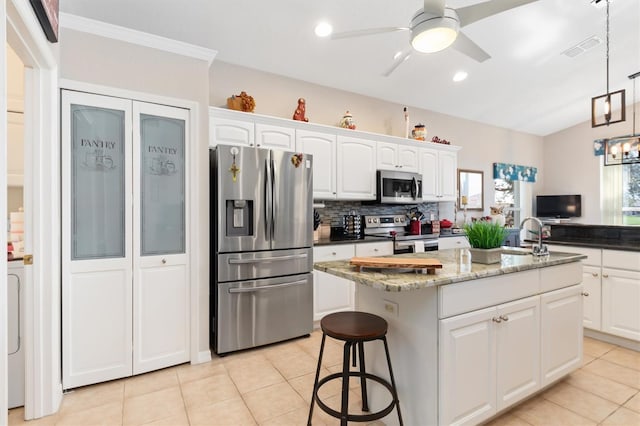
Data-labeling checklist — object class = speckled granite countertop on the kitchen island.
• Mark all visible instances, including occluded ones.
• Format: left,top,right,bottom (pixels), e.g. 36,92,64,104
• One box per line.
314,247,587,291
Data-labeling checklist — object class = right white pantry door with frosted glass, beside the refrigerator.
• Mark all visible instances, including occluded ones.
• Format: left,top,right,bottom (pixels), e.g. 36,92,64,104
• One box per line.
133,102,190,374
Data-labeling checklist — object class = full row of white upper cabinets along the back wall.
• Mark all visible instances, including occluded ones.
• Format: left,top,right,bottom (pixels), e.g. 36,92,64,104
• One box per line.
209,108,460,201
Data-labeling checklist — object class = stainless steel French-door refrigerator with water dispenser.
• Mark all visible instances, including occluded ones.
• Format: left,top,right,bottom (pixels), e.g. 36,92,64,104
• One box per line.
210,145,313,354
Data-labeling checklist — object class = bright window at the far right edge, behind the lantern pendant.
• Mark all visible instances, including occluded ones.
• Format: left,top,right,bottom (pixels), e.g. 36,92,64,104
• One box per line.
601,163,640,225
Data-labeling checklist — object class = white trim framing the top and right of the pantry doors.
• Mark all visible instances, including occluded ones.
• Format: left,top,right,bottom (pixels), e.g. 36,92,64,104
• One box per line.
59,79,211,364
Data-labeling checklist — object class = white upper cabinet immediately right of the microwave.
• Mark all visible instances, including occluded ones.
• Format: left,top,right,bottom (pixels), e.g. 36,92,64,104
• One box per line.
420,148,458,202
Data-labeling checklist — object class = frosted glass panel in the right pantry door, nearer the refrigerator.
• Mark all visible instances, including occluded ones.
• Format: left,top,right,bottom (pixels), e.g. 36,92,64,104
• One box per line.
140,114,185,256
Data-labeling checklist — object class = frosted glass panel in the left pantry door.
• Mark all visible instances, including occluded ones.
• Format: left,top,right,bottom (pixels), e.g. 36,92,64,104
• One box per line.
71,104,126,260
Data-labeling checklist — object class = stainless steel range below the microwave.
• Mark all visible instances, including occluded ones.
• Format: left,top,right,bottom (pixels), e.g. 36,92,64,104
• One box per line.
364,215,439,254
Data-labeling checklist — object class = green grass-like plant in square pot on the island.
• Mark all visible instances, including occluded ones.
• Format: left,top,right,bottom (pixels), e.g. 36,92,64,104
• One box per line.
464,220,509,264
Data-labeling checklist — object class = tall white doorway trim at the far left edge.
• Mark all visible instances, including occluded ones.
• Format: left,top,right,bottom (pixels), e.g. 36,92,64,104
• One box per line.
5,0,62,423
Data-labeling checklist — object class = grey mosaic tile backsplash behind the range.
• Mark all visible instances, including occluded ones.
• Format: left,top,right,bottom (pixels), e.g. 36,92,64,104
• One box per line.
315,201,438,226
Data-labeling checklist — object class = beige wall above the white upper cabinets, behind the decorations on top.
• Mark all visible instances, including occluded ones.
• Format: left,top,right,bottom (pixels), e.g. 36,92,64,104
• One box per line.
209,61,544,218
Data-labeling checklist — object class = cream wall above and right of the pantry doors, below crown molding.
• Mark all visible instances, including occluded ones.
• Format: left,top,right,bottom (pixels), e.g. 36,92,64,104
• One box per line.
59,28,209,352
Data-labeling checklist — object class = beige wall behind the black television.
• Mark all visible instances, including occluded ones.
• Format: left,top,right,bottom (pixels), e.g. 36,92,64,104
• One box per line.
540,102,640,224
